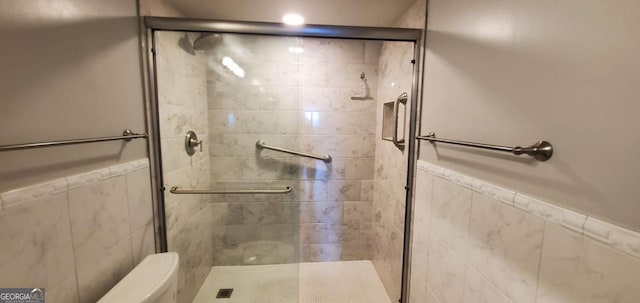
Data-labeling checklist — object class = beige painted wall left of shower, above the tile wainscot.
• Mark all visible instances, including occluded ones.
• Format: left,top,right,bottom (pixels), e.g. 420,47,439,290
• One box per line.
0,0,147,191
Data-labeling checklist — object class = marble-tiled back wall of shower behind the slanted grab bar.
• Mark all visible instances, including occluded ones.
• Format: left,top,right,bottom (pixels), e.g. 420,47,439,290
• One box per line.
207,35,380,265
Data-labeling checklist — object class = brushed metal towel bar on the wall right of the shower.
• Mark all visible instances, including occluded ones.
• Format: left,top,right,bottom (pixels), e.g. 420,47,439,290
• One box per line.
417,132,553,161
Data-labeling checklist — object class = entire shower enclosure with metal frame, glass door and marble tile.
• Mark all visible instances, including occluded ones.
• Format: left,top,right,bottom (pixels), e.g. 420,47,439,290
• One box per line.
146,18,421,303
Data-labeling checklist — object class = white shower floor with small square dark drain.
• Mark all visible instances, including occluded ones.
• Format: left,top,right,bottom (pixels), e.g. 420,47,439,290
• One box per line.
193,261,391,303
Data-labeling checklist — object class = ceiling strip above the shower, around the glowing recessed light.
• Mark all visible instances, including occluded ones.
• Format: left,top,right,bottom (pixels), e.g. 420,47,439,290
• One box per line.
169,0,415,27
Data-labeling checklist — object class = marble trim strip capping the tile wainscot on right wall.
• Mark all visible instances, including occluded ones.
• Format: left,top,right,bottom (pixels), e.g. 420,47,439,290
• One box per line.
417,160,640,258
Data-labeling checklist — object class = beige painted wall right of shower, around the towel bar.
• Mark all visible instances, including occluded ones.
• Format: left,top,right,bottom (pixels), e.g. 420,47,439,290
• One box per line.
420,0,640,230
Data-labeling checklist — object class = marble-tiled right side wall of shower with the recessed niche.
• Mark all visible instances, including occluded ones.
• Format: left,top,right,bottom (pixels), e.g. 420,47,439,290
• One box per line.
372,1,426,302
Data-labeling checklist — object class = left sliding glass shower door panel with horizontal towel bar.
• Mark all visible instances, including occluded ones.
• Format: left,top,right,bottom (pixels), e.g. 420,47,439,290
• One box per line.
155,31,300,302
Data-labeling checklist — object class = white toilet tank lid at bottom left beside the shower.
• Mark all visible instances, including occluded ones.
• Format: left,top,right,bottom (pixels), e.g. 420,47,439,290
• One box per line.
98,252,179,303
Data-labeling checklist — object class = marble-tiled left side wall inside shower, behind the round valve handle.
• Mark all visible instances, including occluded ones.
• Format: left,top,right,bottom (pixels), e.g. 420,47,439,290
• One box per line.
156,32,213,302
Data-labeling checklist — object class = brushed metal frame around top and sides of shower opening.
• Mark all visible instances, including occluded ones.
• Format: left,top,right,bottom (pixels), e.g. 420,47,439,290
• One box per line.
144,16,425,303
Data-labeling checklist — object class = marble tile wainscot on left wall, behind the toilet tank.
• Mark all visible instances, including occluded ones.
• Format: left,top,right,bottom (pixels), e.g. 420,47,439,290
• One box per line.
0,159,155,303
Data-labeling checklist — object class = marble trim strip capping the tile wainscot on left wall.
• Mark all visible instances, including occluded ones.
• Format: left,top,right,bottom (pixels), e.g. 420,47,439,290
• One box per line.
0,159,149,211
